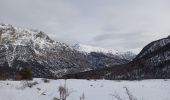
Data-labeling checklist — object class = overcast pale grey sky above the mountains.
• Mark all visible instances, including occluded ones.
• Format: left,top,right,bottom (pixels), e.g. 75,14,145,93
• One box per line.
0,0,170,53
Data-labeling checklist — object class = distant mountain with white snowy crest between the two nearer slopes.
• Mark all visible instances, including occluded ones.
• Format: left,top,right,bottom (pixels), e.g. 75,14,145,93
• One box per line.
72,44,136,68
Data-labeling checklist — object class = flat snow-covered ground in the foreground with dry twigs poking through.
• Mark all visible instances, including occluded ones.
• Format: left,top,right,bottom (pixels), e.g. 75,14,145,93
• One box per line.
0,79,170,100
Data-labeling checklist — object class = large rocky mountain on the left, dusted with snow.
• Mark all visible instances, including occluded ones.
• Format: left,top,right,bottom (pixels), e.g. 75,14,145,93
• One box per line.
0,24,93,78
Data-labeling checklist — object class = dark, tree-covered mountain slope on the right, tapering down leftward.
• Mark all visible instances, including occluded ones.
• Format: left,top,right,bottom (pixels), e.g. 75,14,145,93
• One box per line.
63,36,170,80
